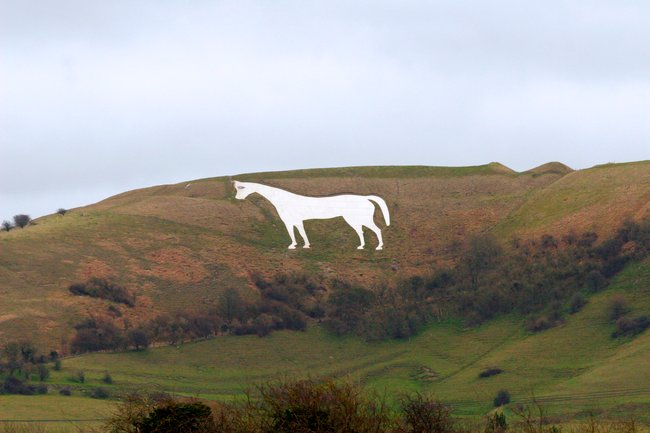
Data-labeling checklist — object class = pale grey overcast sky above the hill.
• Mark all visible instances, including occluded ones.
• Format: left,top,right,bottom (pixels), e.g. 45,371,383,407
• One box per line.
0,0,650,220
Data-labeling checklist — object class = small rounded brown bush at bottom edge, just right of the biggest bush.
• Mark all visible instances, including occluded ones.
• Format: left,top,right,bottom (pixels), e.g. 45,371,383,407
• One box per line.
401,393,454,433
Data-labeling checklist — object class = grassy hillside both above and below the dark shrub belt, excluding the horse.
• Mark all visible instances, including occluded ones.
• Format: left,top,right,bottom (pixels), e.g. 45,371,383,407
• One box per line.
0,162,650,424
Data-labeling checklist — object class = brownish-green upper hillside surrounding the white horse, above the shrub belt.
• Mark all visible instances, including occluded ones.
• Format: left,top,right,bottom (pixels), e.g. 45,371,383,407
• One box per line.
0,162,650,348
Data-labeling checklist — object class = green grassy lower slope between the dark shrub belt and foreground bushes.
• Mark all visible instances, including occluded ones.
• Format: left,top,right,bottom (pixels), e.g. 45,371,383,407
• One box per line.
5,263,650,422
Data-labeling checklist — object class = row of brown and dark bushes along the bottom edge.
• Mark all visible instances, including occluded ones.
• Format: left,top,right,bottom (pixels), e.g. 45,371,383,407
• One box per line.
105,380,640,433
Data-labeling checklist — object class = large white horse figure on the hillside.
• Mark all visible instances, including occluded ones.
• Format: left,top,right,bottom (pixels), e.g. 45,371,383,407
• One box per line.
233,181,390,250
